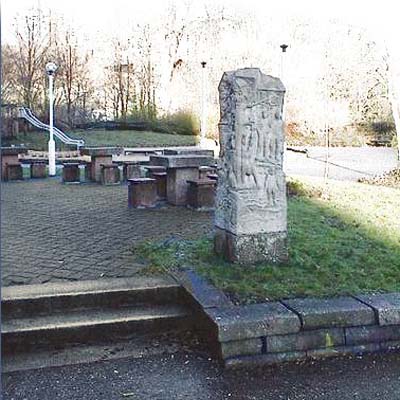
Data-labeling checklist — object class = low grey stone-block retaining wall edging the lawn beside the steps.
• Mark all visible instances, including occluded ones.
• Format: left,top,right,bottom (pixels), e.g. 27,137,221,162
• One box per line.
173,270,400,368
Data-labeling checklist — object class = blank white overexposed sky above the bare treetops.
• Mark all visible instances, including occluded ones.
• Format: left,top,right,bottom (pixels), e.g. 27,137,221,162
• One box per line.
2,0,400,46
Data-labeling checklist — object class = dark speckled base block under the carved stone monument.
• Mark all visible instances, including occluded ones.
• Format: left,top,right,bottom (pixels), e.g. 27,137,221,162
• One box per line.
214,228,288,264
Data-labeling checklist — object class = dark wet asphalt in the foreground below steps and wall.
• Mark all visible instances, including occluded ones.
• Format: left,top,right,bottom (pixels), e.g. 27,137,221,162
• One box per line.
3,351,400,400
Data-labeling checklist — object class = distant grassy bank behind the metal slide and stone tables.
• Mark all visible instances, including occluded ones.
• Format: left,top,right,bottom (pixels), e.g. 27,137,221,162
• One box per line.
3,130,196,151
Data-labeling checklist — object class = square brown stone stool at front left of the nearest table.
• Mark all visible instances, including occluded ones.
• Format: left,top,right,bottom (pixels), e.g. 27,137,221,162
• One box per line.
128,178,157,208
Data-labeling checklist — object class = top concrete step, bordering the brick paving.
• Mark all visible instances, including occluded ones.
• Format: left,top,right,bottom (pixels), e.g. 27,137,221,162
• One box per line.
1,276,182,321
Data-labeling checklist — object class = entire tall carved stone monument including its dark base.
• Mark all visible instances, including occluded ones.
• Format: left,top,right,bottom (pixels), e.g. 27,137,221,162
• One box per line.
215,68,288,264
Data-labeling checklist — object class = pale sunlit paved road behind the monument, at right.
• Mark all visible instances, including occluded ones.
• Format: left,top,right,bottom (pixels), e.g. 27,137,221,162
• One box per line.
284,147,396,181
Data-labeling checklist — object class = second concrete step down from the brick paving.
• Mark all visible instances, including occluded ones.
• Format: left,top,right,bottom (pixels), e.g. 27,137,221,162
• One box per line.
2,305,192,354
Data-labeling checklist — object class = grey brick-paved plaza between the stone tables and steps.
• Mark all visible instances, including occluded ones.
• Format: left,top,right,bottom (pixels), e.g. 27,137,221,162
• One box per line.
1,178,212,286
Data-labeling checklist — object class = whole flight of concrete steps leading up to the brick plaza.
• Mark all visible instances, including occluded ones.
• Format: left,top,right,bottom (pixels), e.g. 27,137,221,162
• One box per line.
2,277,194,370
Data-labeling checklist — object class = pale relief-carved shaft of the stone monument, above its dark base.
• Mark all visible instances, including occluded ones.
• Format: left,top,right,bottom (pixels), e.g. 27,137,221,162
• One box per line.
217,69,286,233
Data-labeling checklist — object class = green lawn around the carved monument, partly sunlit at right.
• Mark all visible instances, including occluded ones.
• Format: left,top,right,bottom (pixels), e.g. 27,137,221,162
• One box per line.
134,177,400,304
